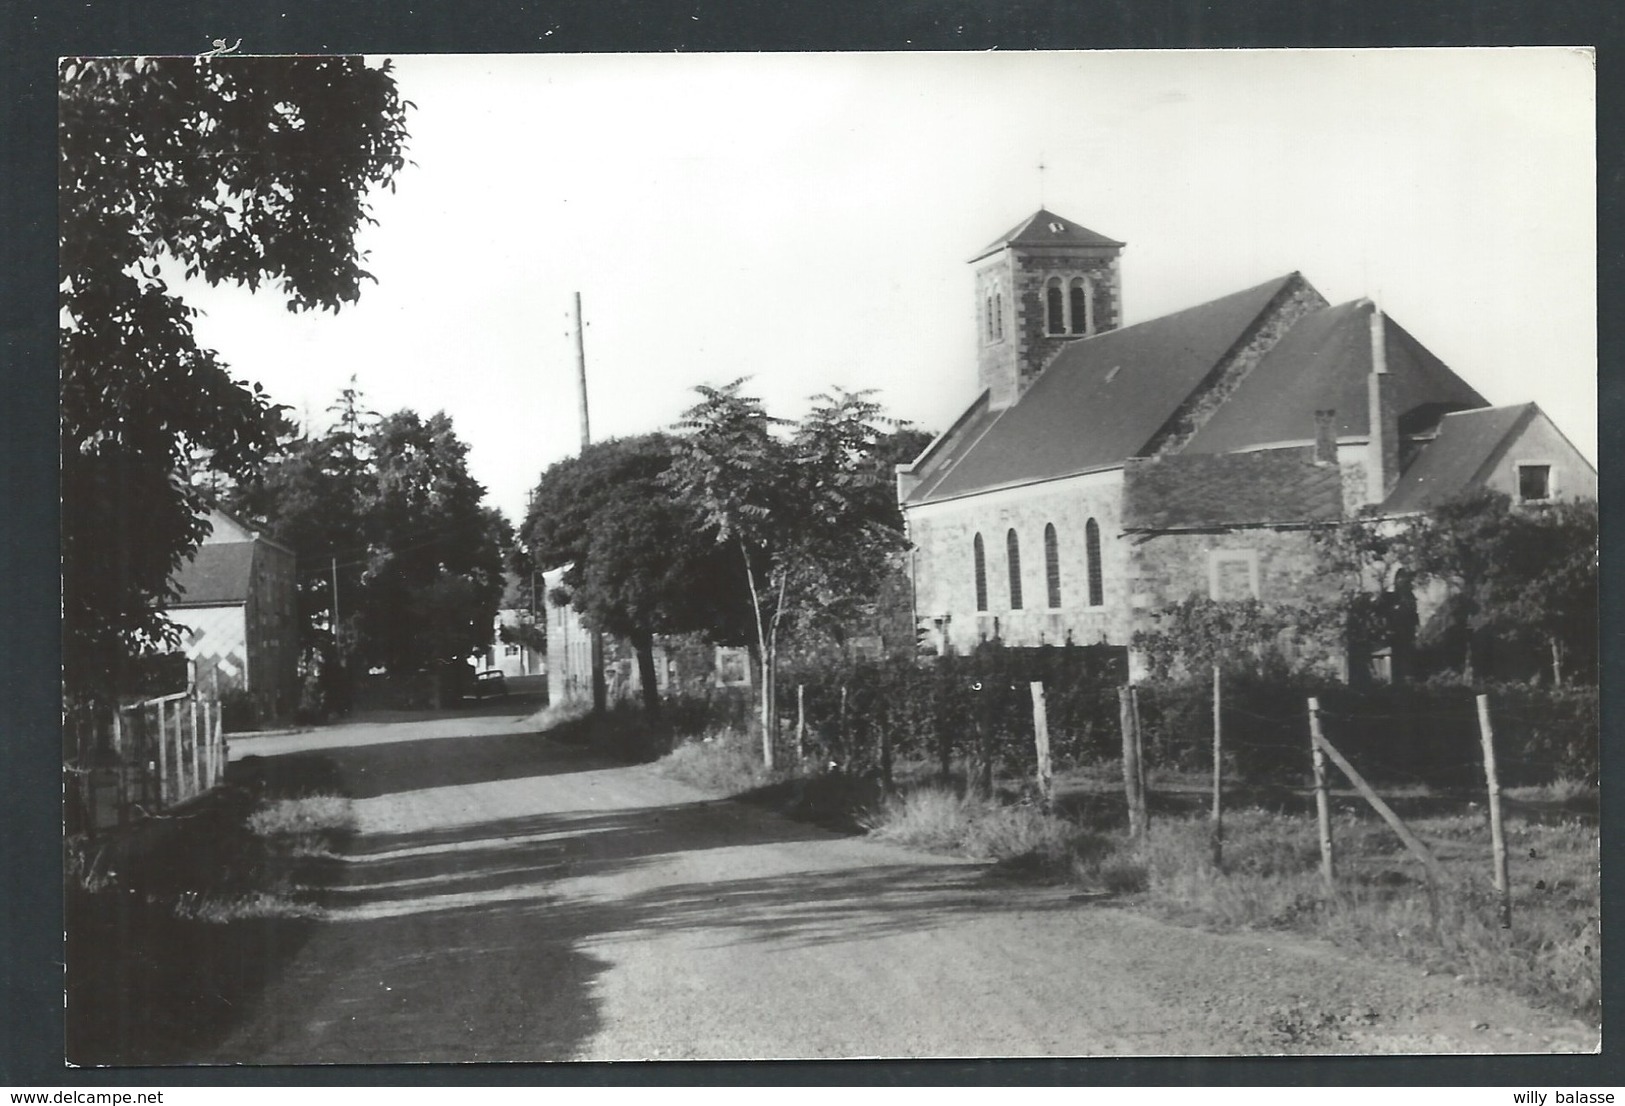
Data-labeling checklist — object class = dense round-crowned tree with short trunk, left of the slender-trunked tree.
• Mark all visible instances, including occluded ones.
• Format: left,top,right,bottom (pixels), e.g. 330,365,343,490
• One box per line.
522,434,741,710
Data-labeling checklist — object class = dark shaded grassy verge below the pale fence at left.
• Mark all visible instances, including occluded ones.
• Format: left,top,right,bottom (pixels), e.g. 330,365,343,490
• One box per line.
65,758,353,1065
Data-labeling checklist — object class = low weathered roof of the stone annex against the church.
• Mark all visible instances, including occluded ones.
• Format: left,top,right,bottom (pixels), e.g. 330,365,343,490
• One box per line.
1123,448,1342,531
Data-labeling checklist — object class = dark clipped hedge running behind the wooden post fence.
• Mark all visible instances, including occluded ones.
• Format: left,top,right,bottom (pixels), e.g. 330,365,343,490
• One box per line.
778,646,1599,788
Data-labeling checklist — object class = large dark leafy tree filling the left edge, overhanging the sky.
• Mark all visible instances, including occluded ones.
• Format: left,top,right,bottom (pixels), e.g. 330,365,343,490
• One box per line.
59,57,406,695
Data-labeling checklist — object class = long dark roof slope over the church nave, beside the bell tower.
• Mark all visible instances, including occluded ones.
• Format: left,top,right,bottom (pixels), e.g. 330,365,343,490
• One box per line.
908,273,1313,503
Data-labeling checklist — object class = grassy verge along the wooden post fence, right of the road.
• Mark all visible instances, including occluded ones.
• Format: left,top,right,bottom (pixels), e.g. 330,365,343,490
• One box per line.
606,701,1601,1023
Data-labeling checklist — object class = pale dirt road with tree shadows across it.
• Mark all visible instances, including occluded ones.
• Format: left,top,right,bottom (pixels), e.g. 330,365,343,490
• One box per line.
197,716,1594,1064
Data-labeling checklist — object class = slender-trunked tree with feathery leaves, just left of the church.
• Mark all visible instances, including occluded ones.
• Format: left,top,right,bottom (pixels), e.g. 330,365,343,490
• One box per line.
668,380,905,767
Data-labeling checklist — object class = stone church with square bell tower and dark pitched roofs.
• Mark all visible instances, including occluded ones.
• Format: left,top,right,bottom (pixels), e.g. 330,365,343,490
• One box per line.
897,210,1597,664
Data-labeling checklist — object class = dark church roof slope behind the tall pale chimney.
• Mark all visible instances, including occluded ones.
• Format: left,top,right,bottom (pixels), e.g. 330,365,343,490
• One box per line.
1181,300,1485,453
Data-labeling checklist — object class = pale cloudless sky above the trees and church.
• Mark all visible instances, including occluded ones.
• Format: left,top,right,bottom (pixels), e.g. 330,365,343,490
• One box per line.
171,49,1597,520
